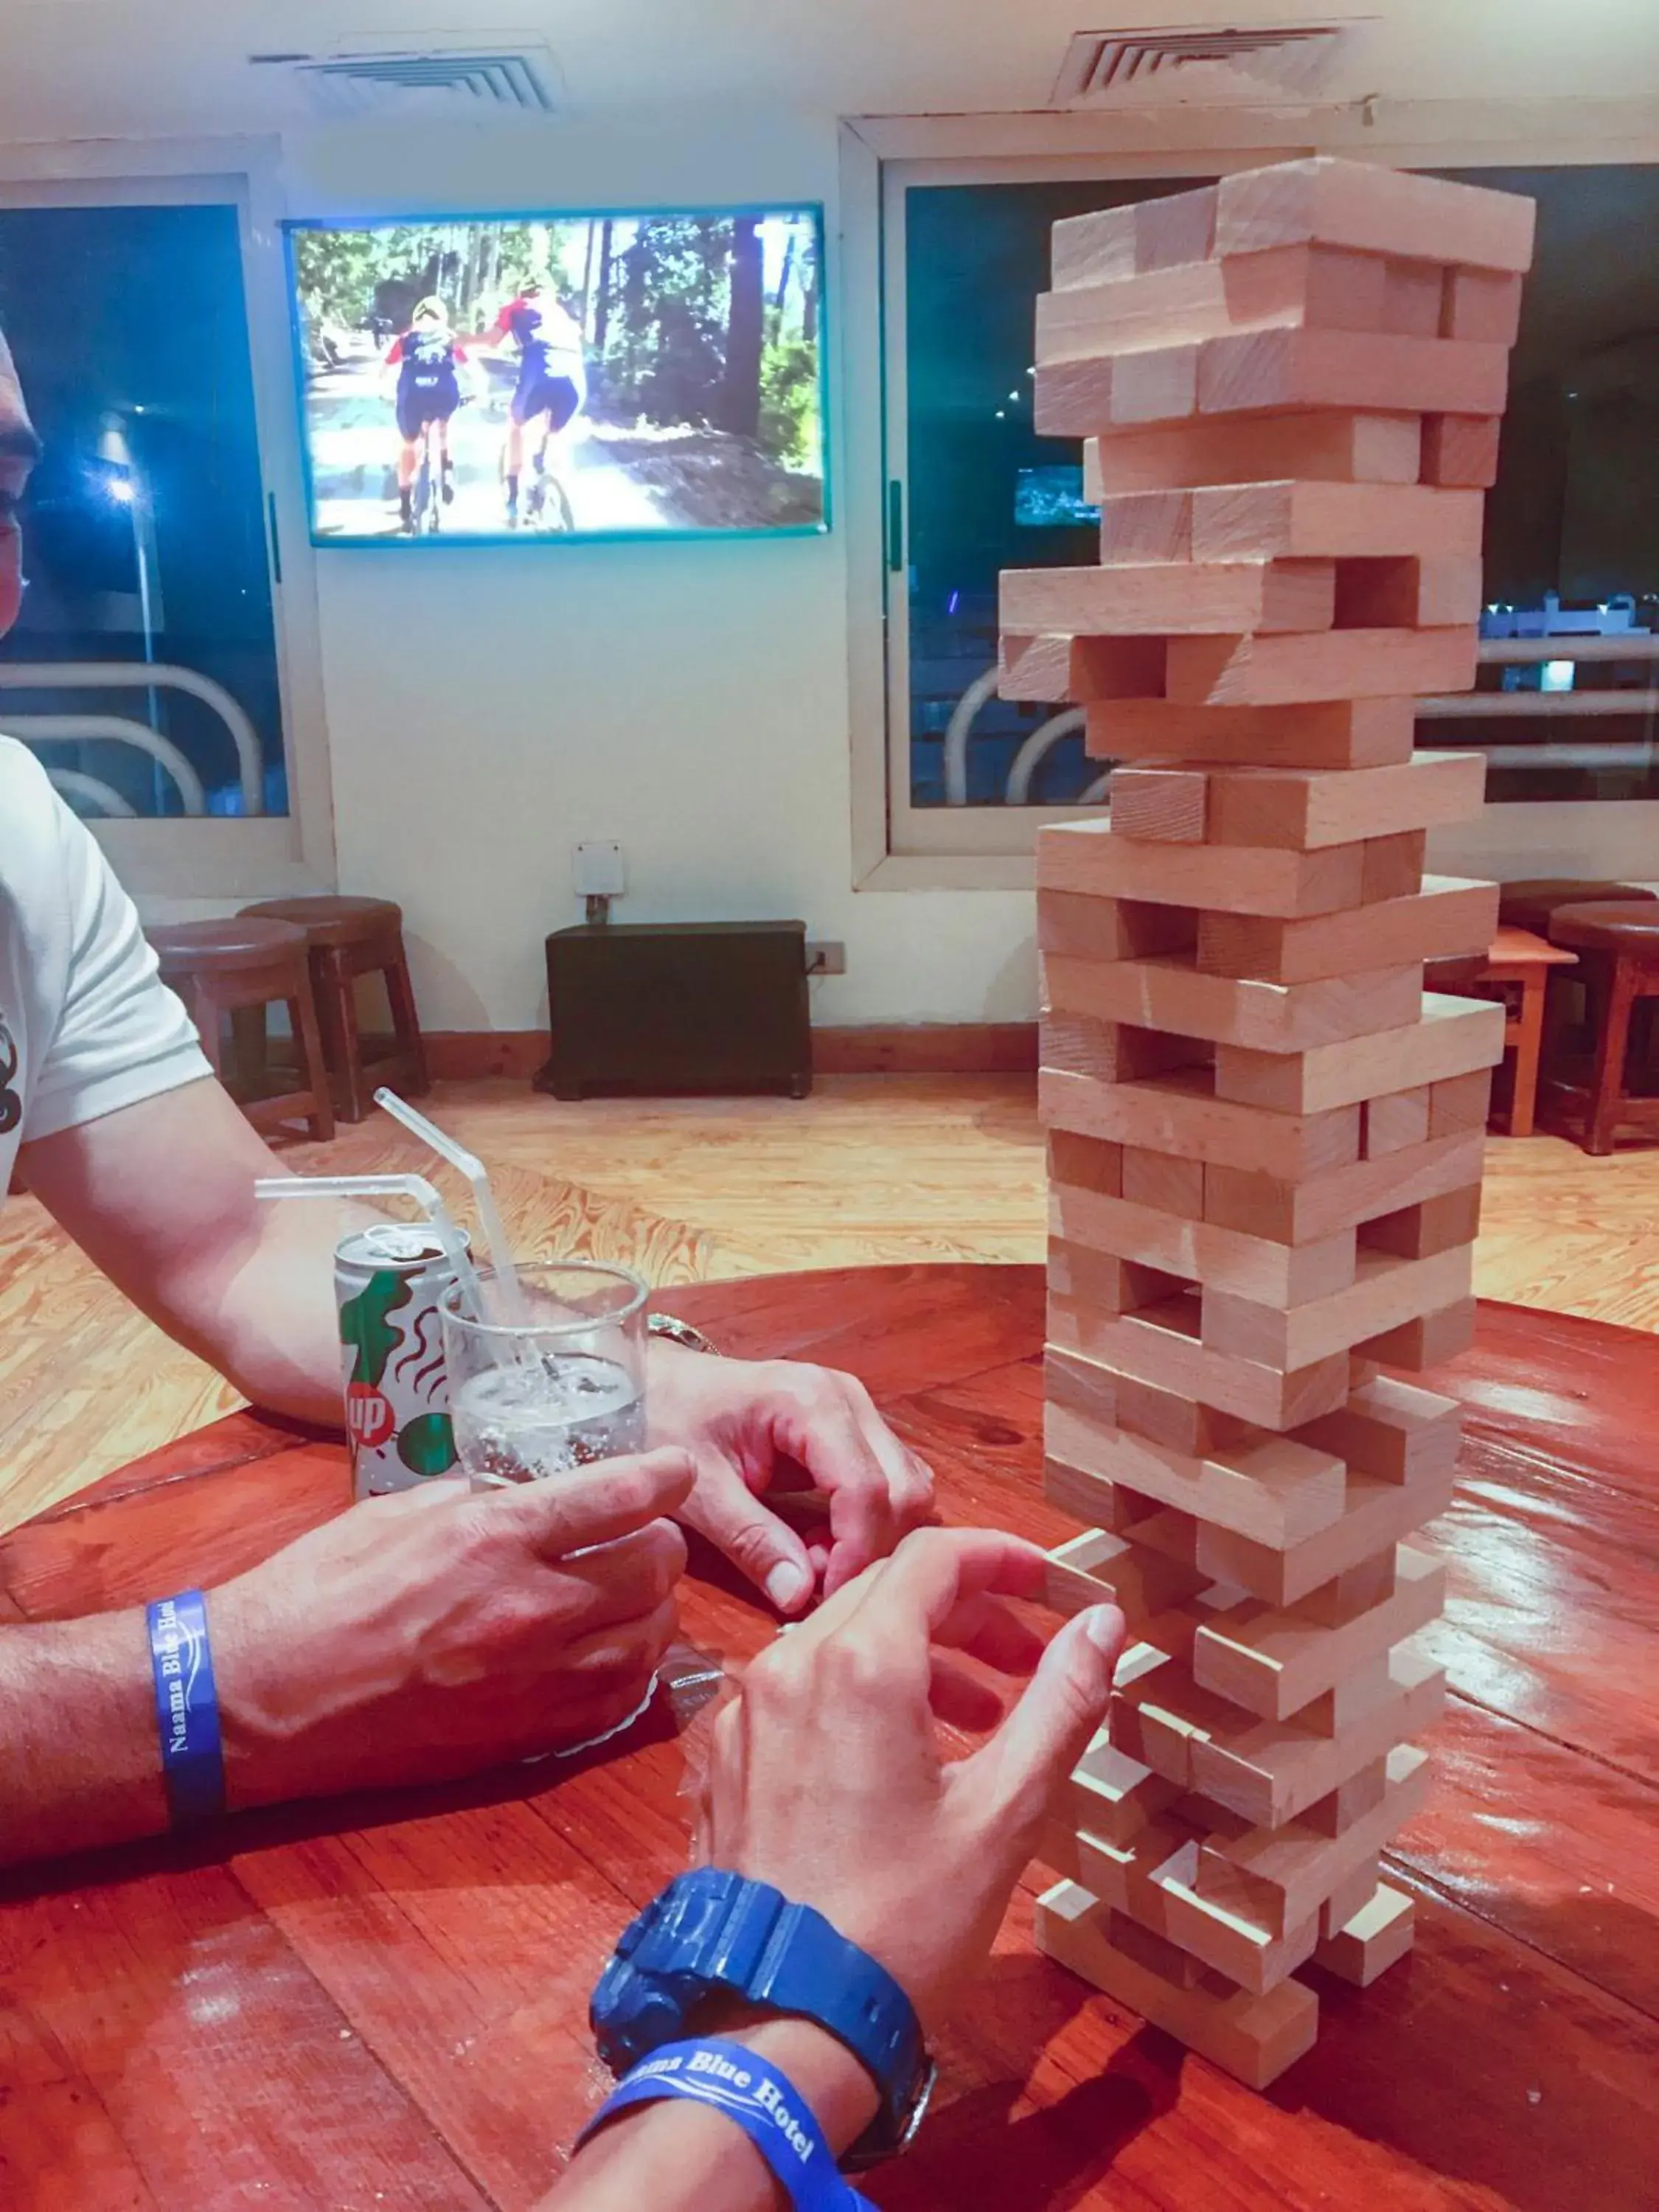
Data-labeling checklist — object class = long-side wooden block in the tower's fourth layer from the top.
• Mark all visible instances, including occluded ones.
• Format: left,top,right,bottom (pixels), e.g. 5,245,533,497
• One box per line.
1084,416,1425,504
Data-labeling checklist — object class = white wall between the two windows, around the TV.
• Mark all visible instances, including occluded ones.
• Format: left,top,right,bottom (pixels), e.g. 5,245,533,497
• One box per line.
285,117,1035,1029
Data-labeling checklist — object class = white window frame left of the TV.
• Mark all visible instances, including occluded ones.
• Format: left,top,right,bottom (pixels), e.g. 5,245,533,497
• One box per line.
0,139,336,900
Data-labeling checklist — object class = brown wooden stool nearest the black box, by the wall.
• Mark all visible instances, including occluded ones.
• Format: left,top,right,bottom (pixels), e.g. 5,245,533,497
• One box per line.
241,898,431,1121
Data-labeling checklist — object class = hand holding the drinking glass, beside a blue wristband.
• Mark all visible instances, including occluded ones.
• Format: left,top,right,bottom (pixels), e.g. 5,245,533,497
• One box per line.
208,1451,692,1807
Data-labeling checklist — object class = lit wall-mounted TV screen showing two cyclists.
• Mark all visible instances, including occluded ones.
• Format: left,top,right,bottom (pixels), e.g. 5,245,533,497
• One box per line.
288,208,830,544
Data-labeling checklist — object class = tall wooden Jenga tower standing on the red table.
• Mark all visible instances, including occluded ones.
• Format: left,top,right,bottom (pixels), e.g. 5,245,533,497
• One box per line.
1002,159,1533,2086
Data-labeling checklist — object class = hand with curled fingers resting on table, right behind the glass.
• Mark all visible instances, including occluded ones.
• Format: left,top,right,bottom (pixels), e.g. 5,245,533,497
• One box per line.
646,1340,933,1613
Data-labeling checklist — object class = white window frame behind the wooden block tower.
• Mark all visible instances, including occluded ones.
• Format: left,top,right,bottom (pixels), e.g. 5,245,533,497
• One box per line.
841,102,1659,891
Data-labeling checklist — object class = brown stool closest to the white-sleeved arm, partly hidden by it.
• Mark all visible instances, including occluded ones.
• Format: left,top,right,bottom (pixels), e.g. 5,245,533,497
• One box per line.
150,914,334,1144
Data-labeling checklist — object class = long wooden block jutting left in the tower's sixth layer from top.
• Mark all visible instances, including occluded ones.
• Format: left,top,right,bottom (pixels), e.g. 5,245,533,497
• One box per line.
1002,557,1336,637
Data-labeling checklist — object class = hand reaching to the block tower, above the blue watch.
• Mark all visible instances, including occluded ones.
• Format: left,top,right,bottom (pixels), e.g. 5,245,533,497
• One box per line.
699,1528,1124,2033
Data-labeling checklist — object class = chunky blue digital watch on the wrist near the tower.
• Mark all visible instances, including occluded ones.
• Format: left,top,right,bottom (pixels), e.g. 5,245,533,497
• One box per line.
588,1867,933,2172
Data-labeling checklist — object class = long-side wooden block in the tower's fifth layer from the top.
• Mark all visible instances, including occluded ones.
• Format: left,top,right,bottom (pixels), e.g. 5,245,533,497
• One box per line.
1186,482,1484,562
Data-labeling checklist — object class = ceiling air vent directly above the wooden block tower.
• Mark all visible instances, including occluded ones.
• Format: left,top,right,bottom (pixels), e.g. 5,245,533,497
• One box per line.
1053,18,1369,108
